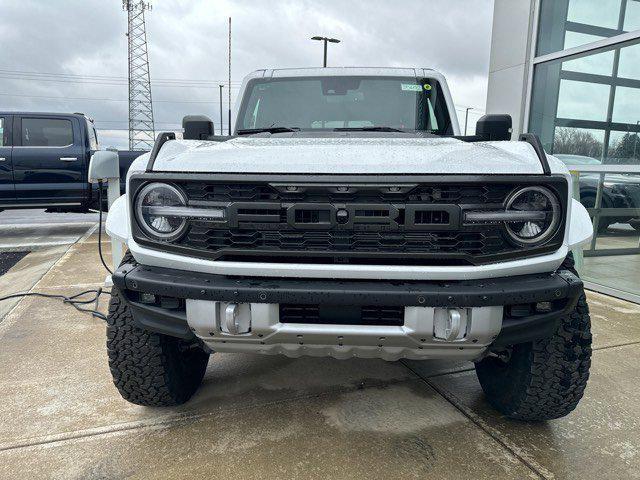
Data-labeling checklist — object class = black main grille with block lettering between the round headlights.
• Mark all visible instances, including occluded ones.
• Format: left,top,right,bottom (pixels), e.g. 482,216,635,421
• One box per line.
129,175,566,265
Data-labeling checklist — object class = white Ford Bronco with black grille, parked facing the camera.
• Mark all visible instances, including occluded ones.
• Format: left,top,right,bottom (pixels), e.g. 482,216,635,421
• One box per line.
107,68,592,420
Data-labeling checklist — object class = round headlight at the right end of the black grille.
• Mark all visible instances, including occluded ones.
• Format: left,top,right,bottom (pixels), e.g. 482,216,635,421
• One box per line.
505,187,560,246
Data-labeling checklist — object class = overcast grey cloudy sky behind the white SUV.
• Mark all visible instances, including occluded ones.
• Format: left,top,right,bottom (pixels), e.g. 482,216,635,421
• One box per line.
0,0,493,148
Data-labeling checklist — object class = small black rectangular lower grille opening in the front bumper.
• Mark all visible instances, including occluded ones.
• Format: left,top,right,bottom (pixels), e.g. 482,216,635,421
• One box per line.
280,303,404,326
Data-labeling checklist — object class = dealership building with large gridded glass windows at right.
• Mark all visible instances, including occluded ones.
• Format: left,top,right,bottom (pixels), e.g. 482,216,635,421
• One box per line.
487,0,640,302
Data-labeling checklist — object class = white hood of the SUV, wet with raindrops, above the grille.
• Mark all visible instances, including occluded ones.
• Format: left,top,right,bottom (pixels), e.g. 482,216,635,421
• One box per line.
153,136,543,175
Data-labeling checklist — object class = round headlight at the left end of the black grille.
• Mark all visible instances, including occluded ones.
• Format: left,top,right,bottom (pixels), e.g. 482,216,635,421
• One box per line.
136,183,187,241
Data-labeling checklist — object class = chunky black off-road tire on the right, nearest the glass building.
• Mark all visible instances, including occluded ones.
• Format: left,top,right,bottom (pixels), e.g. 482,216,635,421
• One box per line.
476,256,591,421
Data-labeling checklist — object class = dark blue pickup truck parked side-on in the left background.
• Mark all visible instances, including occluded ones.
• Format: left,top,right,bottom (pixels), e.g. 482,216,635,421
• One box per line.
0,111,144,212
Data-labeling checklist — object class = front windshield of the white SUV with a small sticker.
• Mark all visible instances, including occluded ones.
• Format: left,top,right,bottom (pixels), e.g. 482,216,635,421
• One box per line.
237,76,453,135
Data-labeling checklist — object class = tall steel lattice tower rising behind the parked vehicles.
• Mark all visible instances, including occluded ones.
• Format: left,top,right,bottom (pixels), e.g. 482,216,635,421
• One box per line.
122,0,155,150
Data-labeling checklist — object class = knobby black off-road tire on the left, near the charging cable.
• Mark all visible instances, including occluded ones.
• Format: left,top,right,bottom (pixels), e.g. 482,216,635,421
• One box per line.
107,254,209,407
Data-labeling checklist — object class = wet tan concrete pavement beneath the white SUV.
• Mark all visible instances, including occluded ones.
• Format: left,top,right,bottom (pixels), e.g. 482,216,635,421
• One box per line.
0,235,640,479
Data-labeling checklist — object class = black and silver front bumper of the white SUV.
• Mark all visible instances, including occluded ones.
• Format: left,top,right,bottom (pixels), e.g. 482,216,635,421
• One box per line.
113,265,582,360
